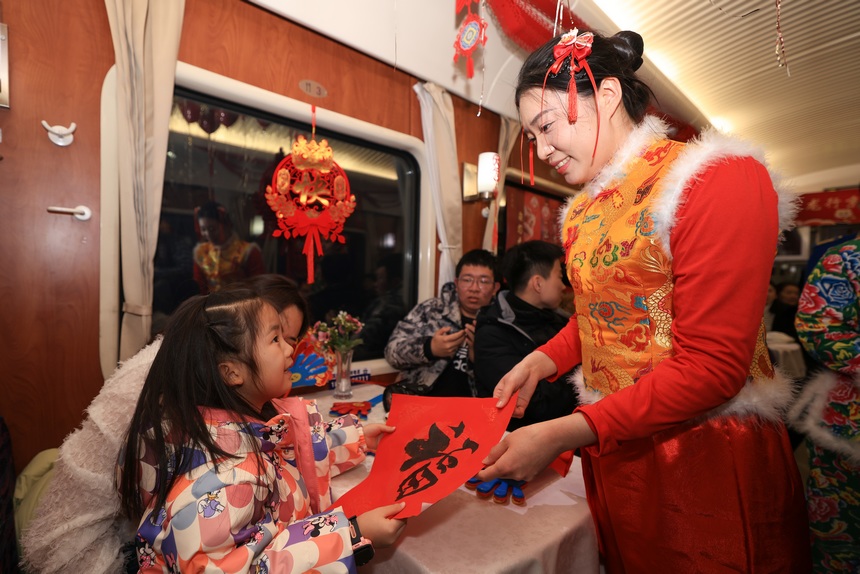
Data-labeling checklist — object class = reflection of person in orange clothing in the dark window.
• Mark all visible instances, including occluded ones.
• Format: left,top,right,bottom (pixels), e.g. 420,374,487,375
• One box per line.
194,201,266,294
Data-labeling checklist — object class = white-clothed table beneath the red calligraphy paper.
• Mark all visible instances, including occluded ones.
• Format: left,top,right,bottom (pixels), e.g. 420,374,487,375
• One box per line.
308,384,599,574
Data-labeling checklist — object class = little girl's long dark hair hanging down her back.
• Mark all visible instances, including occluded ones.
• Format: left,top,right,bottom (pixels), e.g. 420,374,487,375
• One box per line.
118,289,266,520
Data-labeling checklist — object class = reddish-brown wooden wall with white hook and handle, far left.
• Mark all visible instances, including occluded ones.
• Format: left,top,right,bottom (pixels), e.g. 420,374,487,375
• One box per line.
0,0,114,471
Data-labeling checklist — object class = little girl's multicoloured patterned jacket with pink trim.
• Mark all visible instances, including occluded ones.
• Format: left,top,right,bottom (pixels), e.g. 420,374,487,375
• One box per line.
131,399,366,573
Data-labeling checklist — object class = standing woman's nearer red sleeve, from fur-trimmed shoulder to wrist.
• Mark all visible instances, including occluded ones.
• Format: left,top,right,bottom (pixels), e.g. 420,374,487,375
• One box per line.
581,158,779,455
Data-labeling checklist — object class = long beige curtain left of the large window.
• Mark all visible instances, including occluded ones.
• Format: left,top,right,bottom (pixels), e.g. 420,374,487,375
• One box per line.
105,0,185,361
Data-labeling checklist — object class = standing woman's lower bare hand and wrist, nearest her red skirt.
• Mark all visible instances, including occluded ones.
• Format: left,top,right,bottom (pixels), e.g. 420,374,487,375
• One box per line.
476,413,597,481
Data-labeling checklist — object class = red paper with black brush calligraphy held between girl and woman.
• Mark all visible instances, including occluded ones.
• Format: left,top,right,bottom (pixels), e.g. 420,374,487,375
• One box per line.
332,394,516,518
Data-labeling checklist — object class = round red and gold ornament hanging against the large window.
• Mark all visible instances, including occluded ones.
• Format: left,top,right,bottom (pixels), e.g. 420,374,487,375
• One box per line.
266,107,355,284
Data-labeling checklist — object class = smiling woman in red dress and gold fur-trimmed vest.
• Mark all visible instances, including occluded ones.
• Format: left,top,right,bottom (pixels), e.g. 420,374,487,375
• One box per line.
478,30,810,574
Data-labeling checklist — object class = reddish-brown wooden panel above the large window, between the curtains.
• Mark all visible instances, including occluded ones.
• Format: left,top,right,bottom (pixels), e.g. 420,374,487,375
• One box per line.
179,0,421,138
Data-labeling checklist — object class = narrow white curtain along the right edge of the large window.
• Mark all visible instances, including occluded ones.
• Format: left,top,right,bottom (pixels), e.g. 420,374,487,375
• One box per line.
413,82,463,293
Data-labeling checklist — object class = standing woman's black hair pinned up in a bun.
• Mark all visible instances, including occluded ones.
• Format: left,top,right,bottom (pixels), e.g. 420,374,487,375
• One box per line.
515,31,654,123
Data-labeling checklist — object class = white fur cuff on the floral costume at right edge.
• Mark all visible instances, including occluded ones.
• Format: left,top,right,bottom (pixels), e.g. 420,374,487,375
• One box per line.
788,370,860,465
